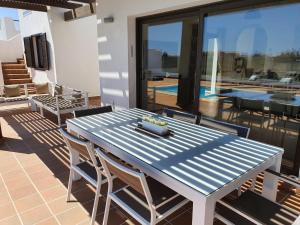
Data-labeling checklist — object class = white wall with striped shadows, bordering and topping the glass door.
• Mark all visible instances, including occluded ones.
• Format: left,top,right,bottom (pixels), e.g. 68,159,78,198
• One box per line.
97,0,221,108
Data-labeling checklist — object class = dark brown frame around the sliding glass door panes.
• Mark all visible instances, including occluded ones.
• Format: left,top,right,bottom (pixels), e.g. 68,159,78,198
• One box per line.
136,0,300,175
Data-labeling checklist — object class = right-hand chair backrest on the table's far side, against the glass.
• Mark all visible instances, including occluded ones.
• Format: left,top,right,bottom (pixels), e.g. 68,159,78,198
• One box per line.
200,116,250,138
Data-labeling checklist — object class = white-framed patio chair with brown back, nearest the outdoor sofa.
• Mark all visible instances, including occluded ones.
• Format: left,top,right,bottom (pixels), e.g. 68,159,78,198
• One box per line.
60,129,107,225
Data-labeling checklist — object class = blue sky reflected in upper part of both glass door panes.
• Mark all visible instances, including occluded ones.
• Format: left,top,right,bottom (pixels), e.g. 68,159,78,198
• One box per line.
148,3,300,56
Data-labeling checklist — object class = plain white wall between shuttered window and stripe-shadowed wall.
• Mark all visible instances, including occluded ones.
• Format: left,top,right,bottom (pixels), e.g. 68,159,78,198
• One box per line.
50,10,100,96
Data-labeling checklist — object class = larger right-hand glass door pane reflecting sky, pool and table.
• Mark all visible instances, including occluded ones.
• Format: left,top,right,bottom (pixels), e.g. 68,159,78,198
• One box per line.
199,4,300,174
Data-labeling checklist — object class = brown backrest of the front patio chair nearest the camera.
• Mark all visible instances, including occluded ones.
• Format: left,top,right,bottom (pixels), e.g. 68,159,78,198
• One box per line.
96,149,152,200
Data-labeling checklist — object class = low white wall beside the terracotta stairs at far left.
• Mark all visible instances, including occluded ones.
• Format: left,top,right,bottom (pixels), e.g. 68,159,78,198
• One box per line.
0,34,24,62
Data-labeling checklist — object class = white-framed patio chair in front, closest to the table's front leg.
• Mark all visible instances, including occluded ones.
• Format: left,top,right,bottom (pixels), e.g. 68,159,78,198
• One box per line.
96,149,189,225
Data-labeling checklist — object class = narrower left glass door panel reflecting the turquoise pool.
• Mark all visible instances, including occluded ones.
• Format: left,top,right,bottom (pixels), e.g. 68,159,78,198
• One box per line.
141,17,199,111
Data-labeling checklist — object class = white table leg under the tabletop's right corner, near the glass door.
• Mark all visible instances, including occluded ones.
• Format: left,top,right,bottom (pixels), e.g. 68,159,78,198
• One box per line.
262,155,282,202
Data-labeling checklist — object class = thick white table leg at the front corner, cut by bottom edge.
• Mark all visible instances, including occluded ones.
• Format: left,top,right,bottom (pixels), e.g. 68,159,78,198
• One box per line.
192,200,215,225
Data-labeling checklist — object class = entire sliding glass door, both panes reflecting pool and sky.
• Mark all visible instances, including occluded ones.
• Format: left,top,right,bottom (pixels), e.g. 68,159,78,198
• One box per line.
138,0,300,174
